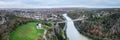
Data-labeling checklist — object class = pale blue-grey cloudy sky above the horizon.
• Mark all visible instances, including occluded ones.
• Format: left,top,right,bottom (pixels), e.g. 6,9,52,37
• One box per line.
0,0,120,8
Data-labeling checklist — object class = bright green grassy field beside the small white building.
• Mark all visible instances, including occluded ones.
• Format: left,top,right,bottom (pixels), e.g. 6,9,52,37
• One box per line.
9,22,44,40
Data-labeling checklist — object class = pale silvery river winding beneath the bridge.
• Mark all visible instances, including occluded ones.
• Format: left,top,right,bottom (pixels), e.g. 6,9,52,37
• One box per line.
63,14,88,40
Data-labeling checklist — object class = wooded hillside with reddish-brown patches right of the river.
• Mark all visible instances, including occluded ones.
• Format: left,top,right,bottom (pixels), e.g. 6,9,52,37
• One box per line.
67,9,120,40
